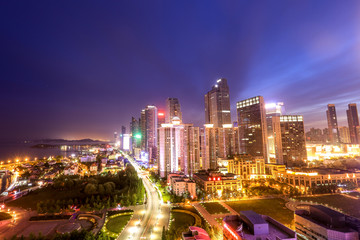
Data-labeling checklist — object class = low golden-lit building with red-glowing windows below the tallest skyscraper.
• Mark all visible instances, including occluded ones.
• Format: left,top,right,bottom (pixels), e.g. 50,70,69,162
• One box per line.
194,172,241,195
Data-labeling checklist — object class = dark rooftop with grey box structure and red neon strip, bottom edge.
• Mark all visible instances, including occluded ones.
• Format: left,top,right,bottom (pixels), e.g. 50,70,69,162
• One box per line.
222,211,296,240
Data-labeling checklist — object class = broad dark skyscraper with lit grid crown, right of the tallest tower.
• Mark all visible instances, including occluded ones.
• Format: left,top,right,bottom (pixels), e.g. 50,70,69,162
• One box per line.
236,96,268,160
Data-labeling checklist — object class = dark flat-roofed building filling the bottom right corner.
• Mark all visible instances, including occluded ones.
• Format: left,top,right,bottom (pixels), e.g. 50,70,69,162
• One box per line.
295,205,360,240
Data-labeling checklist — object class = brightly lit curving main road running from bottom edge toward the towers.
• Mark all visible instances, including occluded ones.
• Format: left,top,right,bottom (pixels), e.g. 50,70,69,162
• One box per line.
117,154,170,240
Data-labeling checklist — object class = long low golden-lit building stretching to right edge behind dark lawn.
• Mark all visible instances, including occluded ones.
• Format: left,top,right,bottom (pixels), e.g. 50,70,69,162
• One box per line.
274,168,360,191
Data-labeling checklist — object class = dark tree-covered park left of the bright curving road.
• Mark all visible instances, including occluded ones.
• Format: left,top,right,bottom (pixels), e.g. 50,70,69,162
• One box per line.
10,165,145,214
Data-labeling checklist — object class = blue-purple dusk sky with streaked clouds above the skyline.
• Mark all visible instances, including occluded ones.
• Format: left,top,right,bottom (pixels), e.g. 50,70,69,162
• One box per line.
0,0,360,139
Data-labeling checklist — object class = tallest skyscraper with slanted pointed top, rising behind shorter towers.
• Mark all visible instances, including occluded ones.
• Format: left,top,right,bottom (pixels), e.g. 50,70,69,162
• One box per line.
205,78,231,127
